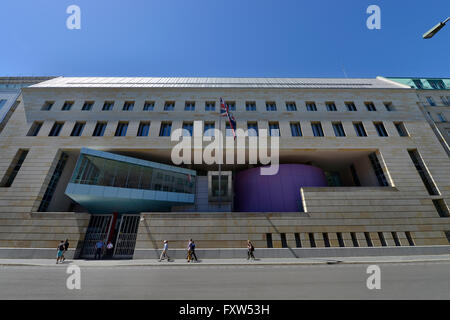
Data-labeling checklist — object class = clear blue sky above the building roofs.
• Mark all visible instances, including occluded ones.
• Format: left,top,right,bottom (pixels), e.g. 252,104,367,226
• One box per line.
0,0,450,78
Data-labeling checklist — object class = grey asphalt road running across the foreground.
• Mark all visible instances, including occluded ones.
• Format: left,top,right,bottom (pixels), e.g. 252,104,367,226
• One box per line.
0,261,450,300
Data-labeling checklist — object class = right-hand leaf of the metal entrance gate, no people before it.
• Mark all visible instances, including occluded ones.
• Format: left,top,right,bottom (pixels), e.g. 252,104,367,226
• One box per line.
114,214,140,259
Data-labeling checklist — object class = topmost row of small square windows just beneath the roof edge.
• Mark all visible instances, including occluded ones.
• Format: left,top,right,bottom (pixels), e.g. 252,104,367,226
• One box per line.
41,101,394,111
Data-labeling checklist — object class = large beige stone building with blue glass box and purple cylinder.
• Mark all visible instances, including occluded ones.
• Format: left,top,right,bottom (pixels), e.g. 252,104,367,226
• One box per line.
0,77,450,257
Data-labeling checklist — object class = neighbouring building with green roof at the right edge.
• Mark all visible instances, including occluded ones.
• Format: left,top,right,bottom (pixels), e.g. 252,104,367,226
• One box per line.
387,78,450,156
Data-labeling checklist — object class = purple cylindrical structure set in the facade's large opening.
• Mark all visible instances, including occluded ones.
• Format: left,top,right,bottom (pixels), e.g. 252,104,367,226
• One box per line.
234,164,328,212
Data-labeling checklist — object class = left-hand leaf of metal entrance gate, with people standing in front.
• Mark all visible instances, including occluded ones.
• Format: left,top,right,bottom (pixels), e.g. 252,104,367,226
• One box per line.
80,214,113,259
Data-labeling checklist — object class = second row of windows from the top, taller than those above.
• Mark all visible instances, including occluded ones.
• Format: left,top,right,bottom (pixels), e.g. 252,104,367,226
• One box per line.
27,121,409,137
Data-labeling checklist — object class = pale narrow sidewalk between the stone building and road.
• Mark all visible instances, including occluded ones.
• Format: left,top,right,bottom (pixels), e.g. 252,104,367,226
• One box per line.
0,255,450,267
